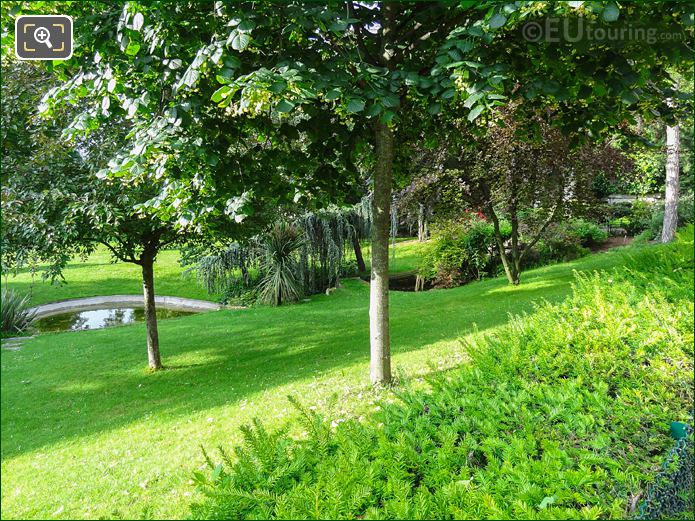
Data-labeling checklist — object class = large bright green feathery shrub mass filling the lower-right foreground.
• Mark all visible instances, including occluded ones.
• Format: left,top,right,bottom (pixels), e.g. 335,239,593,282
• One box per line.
192,226,693,519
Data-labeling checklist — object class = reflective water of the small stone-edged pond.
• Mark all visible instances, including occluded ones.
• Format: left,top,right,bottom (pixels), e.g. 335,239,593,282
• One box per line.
34,307,195,331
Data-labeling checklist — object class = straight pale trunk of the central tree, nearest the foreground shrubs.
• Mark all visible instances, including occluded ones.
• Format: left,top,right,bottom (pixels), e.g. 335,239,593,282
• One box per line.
369,121,394,383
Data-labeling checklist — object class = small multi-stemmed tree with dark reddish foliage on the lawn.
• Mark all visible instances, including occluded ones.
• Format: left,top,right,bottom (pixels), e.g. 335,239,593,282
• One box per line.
445,108,592,284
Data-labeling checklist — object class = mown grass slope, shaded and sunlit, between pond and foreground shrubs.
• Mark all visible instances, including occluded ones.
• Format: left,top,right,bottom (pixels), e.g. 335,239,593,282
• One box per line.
2,245,640,518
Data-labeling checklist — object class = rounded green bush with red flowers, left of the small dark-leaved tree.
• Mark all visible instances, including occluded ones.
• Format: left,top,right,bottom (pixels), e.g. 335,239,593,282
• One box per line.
419,214,511,288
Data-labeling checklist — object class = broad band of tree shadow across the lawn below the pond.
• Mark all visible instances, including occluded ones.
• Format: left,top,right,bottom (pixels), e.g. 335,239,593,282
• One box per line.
1,246,632,459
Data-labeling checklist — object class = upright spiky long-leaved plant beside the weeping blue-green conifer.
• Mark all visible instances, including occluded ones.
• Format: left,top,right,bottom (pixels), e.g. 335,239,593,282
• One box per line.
259,222,302,306
